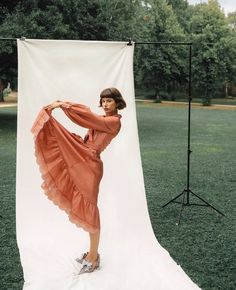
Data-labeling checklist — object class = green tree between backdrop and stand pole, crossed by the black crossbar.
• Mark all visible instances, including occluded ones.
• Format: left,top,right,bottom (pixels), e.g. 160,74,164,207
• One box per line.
136,0,187,95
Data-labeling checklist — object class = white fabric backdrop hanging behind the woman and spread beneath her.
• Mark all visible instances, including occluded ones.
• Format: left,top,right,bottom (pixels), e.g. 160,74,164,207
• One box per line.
16,39,199,290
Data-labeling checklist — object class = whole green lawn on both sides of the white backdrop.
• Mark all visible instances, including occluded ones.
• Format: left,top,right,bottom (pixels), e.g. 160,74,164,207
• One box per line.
0,104,236,290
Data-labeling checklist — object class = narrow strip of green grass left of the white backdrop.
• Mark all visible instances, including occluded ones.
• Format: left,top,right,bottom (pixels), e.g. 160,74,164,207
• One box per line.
0,108,23,290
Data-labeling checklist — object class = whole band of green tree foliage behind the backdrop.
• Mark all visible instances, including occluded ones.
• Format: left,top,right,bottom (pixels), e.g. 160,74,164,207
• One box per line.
0,0,236,99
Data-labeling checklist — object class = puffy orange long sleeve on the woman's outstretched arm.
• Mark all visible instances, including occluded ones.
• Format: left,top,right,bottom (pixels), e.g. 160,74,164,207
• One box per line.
61,102,120,134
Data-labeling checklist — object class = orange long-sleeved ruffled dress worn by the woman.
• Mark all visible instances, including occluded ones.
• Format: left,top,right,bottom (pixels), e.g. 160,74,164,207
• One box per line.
31,102,121,233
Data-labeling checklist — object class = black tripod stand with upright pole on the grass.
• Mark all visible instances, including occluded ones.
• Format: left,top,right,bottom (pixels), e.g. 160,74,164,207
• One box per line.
162,43,225,225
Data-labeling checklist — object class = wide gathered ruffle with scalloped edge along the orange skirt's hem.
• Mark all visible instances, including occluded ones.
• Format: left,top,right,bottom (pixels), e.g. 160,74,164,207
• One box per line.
31,109,100,232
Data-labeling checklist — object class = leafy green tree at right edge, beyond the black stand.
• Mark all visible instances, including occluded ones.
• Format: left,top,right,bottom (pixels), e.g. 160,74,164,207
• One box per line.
190,0,236,105
